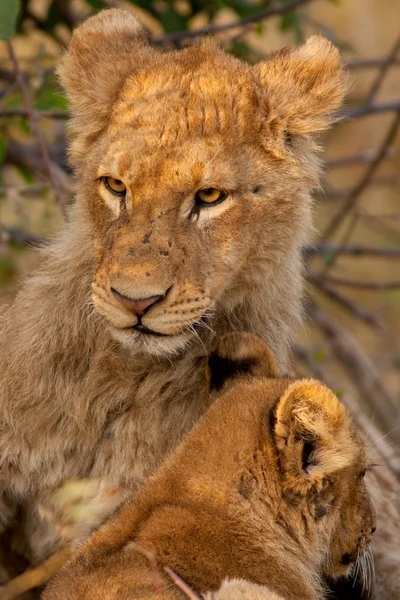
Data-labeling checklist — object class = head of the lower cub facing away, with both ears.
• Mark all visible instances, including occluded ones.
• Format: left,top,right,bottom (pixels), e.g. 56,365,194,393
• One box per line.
206,333,375,578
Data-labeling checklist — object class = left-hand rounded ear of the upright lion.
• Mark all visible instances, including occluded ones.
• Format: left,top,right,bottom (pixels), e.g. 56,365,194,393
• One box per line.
58,9,154,159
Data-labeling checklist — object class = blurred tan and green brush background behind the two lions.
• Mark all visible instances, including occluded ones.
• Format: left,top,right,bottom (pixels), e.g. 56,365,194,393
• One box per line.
0,0,400,475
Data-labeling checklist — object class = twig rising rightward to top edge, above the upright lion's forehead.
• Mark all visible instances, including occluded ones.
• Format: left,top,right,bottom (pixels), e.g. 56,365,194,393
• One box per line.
152,0,315,46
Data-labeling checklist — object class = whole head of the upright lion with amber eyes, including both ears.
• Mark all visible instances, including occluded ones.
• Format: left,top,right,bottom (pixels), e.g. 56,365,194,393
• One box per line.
60,10,344,354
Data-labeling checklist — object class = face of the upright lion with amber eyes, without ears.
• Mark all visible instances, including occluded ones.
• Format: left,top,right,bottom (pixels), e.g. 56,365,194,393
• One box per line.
90,125,279,353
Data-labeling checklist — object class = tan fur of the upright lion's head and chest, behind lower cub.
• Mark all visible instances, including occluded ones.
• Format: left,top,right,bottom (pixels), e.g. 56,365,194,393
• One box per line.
0,10,345,563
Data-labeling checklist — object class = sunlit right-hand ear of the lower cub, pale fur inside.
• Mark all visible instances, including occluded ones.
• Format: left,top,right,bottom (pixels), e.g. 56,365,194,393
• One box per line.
274,379,360,493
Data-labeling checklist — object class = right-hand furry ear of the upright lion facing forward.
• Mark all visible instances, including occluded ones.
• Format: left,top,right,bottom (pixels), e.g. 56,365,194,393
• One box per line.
254,35,348,154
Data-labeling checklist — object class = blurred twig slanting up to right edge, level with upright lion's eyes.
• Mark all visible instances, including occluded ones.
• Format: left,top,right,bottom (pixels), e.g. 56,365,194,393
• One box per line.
322,107,400,241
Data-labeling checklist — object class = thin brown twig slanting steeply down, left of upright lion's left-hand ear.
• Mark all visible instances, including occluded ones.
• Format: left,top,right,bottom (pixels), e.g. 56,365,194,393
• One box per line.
7,40,67,218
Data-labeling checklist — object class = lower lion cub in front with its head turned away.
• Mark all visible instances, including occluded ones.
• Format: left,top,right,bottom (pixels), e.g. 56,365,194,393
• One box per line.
43,333,375,600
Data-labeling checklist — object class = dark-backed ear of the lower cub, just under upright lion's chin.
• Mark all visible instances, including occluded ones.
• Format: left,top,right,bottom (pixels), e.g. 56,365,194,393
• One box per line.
207,332,278,390
